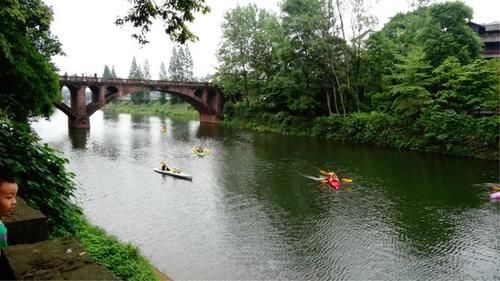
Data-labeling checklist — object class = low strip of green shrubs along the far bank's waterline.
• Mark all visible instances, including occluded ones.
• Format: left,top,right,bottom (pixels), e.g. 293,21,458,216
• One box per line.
223,112,500,160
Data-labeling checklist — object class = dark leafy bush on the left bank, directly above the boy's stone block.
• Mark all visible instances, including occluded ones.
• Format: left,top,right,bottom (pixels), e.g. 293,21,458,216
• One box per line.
0,114,81,235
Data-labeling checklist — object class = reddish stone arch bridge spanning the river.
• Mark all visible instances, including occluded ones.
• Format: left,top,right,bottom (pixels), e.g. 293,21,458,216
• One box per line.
56,76,224,128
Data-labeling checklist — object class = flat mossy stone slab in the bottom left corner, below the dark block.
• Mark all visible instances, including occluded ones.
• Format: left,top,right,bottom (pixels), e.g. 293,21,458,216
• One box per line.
4,238,119,280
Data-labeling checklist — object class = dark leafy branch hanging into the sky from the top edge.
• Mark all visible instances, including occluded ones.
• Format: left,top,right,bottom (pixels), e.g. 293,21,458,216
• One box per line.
115,0,210,44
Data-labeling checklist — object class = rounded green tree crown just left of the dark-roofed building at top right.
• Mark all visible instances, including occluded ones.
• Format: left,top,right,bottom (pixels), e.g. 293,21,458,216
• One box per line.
381,1,481,67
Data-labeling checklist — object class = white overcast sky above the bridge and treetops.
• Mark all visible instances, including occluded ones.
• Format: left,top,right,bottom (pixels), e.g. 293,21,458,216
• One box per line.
44,0,500,79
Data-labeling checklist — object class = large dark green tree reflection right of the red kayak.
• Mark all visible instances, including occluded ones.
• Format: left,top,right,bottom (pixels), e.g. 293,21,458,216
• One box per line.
337,144,491,254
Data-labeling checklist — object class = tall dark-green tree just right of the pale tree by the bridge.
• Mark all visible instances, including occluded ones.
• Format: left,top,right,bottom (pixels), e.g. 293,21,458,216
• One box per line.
278,0,329,116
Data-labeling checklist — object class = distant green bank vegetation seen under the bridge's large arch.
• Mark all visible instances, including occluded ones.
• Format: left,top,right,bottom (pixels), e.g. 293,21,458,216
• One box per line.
103,101,199,119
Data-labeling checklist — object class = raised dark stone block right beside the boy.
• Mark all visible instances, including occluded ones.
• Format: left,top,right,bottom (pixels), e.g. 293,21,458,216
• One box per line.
0,197,49,245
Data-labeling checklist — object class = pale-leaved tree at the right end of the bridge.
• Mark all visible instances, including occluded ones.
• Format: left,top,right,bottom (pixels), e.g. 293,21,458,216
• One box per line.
215,5,286,109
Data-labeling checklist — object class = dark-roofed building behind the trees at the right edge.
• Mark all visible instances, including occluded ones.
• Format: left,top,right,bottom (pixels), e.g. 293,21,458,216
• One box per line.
469,21,500,58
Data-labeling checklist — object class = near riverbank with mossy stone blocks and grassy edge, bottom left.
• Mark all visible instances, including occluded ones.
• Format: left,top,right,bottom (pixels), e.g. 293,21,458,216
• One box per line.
0,197,171,280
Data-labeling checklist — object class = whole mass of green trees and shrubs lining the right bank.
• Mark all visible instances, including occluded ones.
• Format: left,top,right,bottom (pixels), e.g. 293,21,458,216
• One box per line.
215,0,500,159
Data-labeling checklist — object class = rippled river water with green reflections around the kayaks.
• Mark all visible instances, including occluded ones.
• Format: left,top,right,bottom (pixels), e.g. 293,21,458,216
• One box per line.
33,111,500,280
